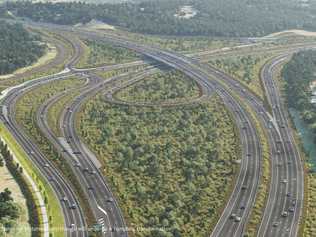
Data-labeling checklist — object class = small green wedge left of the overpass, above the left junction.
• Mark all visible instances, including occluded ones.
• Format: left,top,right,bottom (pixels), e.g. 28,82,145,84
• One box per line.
78,40,138,68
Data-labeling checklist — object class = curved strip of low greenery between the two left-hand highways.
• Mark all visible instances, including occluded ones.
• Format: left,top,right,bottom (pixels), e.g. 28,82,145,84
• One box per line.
16,78,98,230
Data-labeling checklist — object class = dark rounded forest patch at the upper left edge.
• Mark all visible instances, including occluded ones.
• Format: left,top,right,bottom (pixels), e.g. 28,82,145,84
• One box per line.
0,21,46,75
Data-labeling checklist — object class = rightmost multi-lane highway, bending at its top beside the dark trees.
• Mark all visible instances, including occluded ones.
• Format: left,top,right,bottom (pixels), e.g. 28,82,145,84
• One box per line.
259,55,304,236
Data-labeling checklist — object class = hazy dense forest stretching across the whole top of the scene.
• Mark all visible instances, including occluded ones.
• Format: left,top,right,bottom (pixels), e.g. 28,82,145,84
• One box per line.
1,0,316,37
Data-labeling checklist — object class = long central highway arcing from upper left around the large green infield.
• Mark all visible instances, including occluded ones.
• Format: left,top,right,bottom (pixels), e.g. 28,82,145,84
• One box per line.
16,21,274,236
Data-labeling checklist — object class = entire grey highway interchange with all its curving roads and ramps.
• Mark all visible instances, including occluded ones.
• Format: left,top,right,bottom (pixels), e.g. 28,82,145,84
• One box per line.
1,20,312,237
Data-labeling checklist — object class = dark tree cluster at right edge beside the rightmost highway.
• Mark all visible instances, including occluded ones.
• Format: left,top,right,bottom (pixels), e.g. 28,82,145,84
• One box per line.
282,50,316,139
